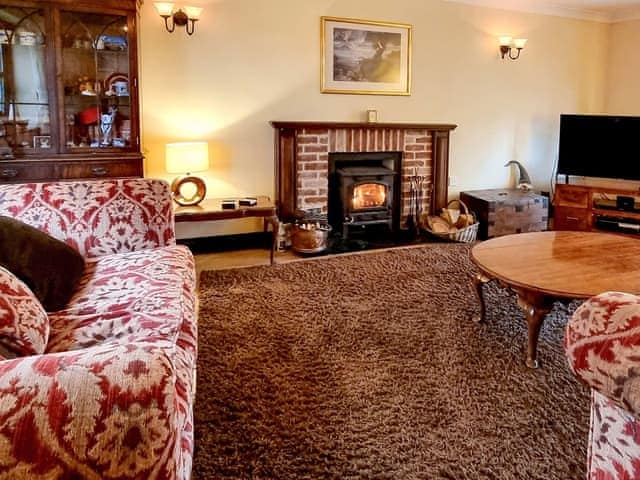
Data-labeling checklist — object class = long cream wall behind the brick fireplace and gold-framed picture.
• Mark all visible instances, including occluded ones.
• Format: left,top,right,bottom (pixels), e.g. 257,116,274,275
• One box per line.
140,0,608,234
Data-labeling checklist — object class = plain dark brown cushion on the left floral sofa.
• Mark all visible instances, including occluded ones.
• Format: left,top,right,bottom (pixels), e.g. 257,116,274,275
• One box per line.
0,216,84,312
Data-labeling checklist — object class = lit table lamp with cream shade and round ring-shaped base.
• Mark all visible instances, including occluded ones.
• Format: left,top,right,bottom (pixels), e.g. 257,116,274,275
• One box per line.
165,142,209,206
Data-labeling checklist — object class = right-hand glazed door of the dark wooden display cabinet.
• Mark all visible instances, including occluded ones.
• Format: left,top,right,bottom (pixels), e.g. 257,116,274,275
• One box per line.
60,11,137,153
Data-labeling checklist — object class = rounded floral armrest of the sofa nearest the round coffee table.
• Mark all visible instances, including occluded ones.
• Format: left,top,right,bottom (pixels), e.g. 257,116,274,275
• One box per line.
564,292,640,419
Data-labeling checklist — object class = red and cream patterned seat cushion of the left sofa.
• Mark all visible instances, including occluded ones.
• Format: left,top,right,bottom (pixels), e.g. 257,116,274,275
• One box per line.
47,246,195,352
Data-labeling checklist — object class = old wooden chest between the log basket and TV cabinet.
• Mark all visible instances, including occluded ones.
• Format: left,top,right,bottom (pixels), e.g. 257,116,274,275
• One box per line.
460,188,549,239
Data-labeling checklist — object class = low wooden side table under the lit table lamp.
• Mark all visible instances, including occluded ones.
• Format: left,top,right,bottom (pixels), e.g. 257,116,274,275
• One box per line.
173,196,279,265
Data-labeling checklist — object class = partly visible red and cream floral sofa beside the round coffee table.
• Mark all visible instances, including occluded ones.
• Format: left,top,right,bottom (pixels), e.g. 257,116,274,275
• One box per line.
564,292,640,480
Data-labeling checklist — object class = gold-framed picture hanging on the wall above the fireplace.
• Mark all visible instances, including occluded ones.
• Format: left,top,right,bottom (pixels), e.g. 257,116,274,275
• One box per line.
320,17,411,95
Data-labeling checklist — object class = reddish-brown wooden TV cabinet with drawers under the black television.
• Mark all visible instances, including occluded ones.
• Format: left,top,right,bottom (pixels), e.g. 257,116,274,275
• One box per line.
553,184,640,231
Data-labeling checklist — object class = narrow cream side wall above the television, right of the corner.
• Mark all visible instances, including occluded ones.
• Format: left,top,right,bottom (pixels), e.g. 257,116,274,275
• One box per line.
606,20,640,115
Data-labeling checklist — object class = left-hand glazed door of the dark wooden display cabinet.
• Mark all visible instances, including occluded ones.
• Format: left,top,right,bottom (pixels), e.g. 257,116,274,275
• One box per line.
0,6,56,156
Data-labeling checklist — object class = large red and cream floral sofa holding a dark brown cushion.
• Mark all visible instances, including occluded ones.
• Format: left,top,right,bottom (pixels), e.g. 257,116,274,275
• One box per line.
0,179,197,479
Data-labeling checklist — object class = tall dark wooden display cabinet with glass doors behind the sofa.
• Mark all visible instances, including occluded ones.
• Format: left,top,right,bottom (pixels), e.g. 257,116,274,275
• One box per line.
0,0,142,183
